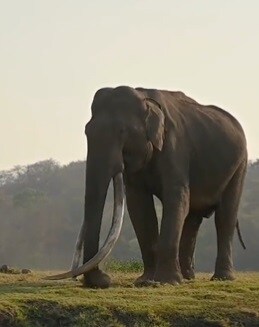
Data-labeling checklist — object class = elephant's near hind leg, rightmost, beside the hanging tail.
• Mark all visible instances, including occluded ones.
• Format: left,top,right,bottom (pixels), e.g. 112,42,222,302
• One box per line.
212,164,246,280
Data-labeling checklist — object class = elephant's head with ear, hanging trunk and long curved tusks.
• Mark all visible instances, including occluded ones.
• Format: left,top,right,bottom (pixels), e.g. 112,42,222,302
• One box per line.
46,86,164,286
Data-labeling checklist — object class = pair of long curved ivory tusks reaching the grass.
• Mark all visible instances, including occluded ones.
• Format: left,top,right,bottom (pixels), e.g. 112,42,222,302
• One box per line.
45,173,125,280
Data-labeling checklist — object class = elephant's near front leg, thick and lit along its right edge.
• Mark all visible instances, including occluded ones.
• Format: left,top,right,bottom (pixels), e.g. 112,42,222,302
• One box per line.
154,187,189,284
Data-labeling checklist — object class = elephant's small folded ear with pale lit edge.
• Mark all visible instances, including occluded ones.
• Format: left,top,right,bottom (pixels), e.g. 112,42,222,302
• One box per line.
145,98,165,151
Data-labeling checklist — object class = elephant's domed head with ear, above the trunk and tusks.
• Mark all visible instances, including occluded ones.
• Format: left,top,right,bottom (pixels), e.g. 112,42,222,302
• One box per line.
85,87,164,176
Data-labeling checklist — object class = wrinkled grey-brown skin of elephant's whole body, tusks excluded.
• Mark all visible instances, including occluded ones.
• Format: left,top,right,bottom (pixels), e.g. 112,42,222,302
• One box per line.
83,86,247,288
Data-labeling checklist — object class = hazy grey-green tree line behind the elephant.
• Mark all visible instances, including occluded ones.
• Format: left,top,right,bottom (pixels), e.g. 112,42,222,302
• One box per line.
0,159,259,271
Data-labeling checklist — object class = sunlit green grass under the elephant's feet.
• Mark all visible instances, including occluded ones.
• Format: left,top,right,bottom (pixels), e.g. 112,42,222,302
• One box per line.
0,263,259,327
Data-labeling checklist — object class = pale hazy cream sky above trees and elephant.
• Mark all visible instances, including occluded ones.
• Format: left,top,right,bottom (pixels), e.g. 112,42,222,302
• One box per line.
0,0,259,169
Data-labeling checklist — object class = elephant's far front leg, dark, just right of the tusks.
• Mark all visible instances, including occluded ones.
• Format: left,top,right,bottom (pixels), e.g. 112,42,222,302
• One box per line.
126,185,158,286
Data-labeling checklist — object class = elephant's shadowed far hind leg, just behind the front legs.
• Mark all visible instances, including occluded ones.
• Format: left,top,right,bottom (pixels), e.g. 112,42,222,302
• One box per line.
179,213,202,279
